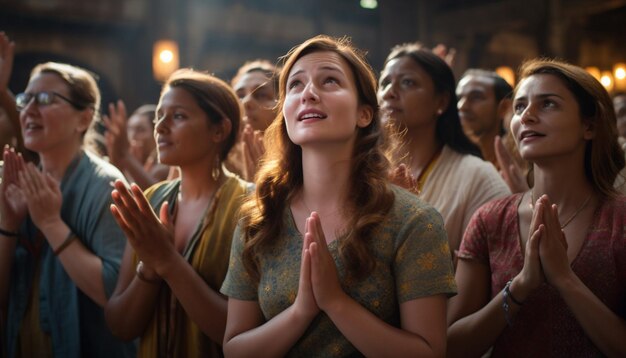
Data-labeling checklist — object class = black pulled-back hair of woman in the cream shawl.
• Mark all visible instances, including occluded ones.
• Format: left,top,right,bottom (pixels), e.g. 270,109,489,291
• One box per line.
385,43,482,157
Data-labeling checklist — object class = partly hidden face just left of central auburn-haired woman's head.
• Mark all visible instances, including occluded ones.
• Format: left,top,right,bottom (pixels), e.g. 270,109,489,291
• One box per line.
233,71,276,131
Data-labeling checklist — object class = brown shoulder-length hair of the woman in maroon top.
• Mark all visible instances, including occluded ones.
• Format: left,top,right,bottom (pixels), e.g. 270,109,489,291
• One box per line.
514,58,626,197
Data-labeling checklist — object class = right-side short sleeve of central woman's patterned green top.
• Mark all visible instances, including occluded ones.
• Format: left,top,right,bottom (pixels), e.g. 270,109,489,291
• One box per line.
394,206,456,303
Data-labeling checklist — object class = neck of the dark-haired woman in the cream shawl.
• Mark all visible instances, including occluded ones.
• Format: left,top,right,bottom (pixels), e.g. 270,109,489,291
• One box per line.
399,126,443,178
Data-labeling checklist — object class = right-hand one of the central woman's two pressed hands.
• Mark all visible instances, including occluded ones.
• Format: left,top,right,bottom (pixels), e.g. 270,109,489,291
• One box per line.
305,211,346,311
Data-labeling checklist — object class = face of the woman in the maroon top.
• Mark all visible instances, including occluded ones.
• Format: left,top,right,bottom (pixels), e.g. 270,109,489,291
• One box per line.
511,74,593,162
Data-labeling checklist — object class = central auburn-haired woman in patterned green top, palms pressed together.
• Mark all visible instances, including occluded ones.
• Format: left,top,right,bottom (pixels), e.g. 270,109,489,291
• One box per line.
222,36,455,356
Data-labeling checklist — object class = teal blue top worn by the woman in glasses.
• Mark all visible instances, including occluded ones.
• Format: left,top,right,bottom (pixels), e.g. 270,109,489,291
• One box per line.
6,153,135,358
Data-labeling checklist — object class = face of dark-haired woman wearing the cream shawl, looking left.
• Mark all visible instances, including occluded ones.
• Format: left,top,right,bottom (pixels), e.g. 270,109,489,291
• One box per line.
378,56,445,128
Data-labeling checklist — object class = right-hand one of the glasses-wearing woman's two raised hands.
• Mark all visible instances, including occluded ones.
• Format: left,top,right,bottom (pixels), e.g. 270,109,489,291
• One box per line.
19,163,63,233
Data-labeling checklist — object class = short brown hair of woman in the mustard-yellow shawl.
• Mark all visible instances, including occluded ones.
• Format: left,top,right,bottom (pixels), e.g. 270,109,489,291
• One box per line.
161,68,241,161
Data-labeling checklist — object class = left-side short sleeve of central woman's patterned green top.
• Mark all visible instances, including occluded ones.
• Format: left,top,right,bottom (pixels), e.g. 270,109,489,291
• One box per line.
220,225,258,301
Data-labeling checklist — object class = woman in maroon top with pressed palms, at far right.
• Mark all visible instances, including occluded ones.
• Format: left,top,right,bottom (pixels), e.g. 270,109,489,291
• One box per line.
448,60,626,356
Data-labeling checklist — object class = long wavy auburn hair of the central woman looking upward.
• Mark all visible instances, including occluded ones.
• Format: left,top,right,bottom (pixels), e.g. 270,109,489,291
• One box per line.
242,35,394,280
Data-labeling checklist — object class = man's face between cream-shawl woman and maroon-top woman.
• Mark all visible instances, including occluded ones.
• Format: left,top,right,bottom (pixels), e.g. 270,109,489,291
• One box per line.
456,75,501,142
